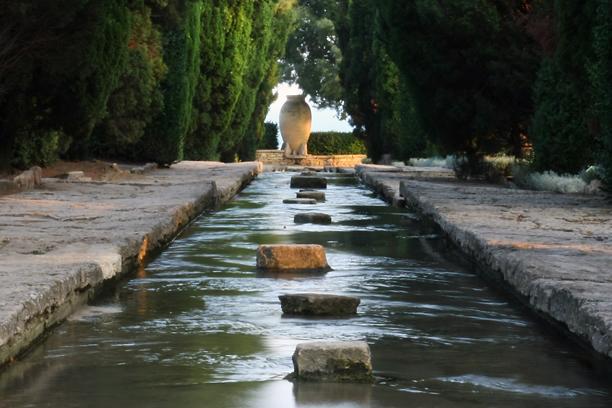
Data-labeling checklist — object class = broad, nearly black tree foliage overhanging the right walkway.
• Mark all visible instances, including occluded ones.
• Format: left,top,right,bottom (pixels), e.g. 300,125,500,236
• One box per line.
376,0,537,163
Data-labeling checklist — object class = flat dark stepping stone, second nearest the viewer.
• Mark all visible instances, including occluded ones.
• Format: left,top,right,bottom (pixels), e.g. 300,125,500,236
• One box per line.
278,293,361,316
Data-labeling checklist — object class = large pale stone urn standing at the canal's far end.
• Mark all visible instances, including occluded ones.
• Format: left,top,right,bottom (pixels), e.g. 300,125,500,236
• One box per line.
279,95,312,157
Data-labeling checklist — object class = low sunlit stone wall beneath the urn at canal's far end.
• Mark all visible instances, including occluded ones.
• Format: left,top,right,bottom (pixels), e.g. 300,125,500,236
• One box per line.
255,150,366,167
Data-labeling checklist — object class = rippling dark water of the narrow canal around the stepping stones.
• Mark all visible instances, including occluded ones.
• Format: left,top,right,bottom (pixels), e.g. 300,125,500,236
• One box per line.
0,173,612,408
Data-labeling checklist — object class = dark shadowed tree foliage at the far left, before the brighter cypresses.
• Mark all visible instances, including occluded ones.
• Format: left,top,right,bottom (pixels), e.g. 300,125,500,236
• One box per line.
0,0,130,166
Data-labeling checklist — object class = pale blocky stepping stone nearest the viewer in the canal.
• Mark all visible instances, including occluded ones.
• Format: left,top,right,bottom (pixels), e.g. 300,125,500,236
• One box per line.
293,341,372,382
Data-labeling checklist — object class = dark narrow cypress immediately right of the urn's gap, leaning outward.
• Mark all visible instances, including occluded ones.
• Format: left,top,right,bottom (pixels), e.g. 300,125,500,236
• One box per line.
339,0,426,160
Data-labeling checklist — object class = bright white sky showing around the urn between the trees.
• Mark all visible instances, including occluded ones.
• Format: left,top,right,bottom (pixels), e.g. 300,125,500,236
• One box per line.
266,82,353,138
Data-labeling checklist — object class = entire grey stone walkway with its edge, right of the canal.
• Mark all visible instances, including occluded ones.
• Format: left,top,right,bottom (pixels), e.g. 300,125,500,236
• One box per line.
360,164,612,358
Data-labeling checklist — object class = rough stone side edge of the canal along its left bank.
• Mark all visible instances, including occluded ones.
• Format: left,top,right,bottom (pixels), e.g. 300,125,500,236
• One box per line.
0,162,263,373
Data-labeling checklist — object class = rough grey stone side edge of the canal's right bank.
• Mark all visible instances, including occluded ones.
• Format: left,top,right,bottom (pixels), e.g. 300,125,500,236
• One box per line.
356,165,612,365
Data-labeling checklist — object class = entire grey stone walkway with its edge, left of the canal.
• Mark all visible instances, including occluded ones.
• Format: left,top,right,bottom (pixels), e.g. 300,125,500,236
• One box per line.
0,162,262,366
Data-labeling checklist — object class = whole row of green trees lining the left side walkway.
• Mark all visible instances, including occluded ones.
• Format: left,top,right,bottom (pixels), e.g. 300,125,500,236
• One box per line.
0,0,295,166
